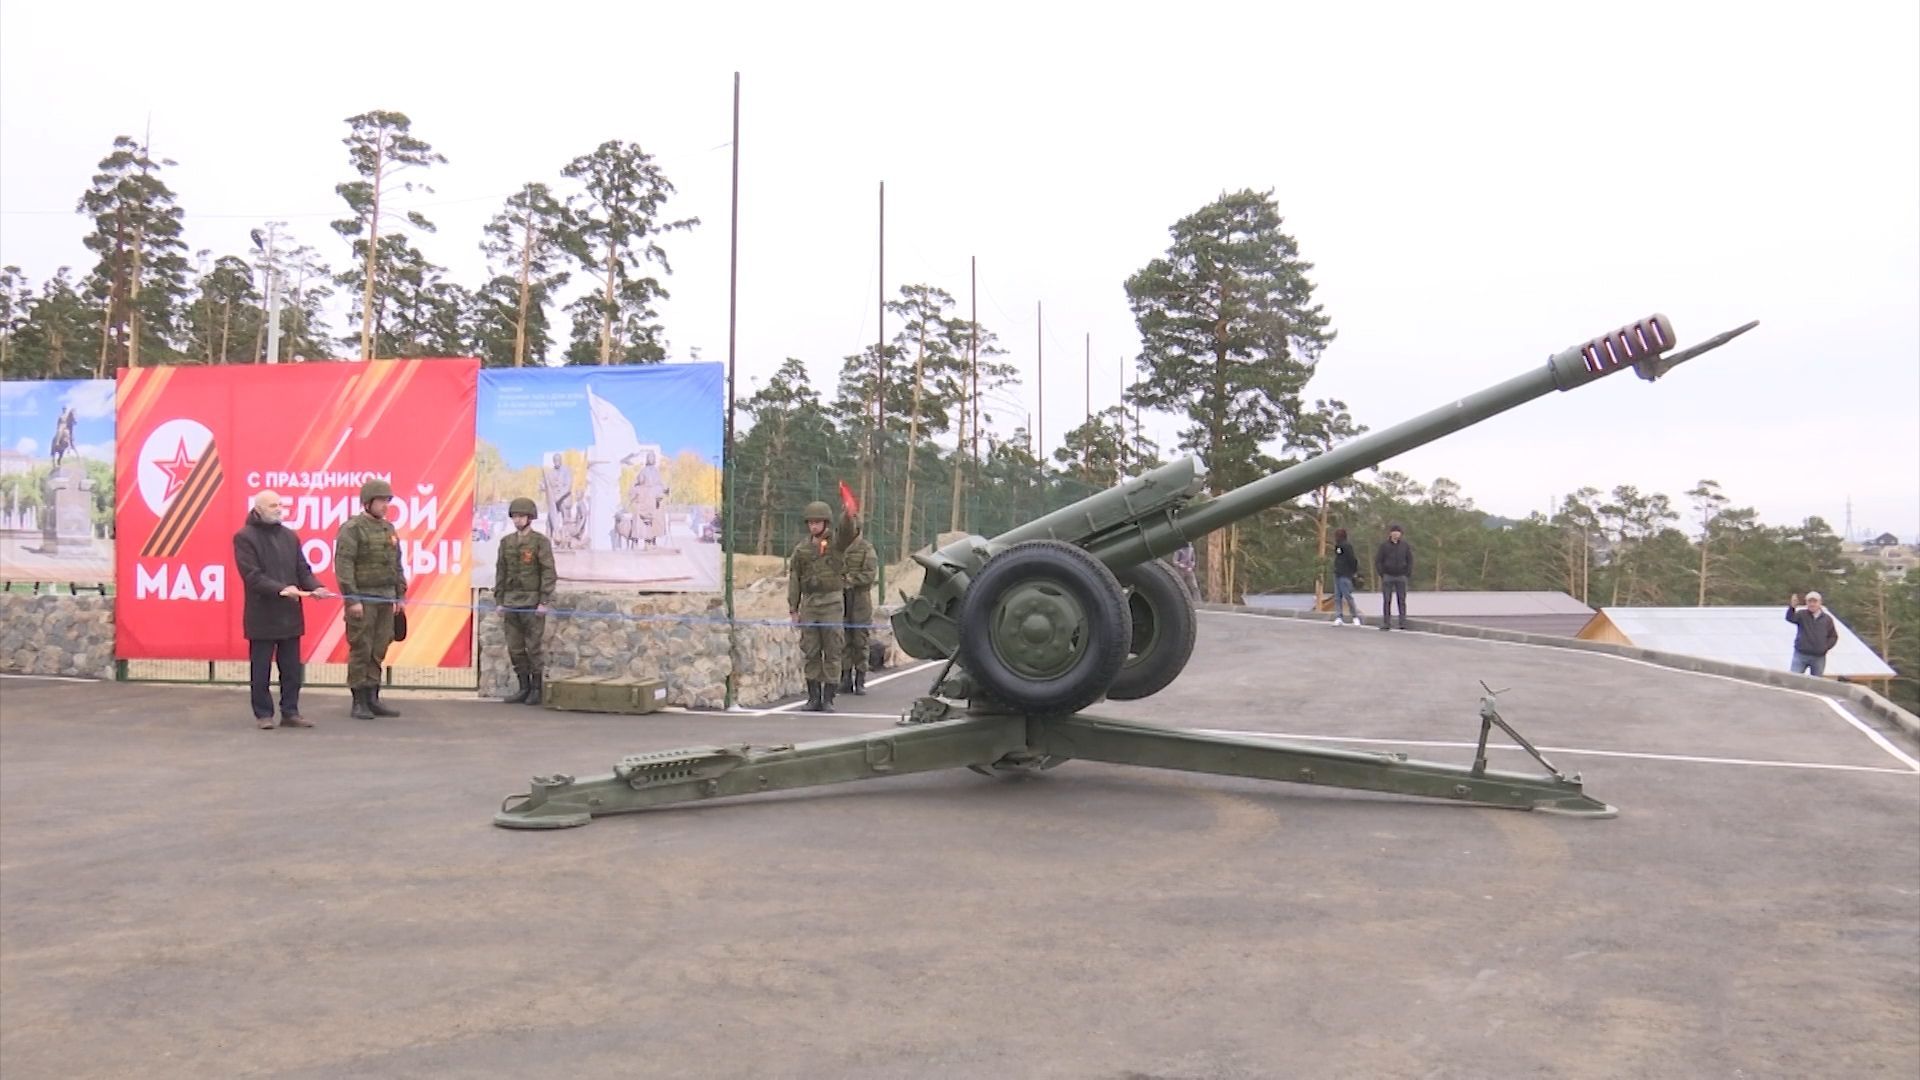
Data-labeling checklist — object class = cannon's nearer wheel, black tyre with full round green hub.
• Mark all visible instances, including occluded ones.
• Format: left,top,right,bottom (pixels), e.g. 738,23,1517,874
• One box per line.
960,540,1131,713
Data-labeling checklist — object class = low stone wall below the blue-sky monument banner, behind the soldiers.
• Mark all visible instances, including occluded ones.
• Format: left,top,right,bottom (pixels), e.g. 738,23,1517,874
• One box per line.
480,592,891,709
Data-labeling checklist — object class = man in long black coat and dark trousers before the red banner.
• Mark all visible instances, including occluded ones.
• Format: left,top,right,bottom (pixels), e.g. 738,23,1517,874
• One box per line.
234,492,332,730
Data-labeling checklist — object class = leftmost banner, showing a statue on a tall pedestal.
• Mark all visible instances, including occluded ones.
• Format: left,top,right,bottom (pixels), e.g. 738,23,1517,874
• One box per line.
0,379,113,586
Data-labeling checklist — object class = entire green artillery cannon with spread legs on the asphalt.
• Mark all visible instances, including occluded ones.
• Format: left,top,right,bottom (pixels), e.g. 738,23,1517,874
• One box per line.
493,315,1759,828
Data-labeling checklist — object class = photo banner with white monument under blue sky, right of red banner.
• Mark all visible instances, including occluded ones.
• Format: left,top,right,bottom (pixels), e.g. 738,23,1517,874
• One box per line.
472,363,726,592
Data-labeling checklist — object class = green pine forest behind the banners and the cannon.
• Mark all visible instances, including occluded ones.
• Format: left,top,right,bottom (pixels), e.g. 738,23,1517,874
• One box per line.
0,111,1920,707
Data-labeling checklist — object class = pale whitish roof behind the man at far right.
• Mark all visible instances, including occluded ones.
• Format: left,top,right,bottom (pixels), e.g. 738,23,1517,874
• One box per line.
1580,603,1893,678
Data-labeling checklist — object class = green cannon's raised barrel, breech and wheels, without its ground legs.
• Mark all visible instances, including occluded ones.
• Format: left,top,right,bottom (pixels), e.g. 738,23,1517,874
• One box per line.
893,315,1757,713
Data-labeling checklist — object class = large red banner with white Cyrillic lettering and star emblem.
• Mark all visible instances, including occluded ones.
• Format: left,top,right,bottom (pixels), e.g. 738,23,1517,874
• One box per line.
113,359,480,667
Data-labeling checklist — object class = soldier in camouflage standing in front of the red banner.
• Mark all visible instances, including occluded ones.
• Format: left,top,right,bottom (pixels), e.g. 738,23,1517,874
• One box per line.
334,479,407,721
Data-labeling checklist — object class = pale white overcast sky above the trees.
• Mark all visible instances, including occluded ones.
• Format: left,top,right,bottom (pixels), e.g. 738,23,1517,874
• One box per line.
0,0,1920,538
